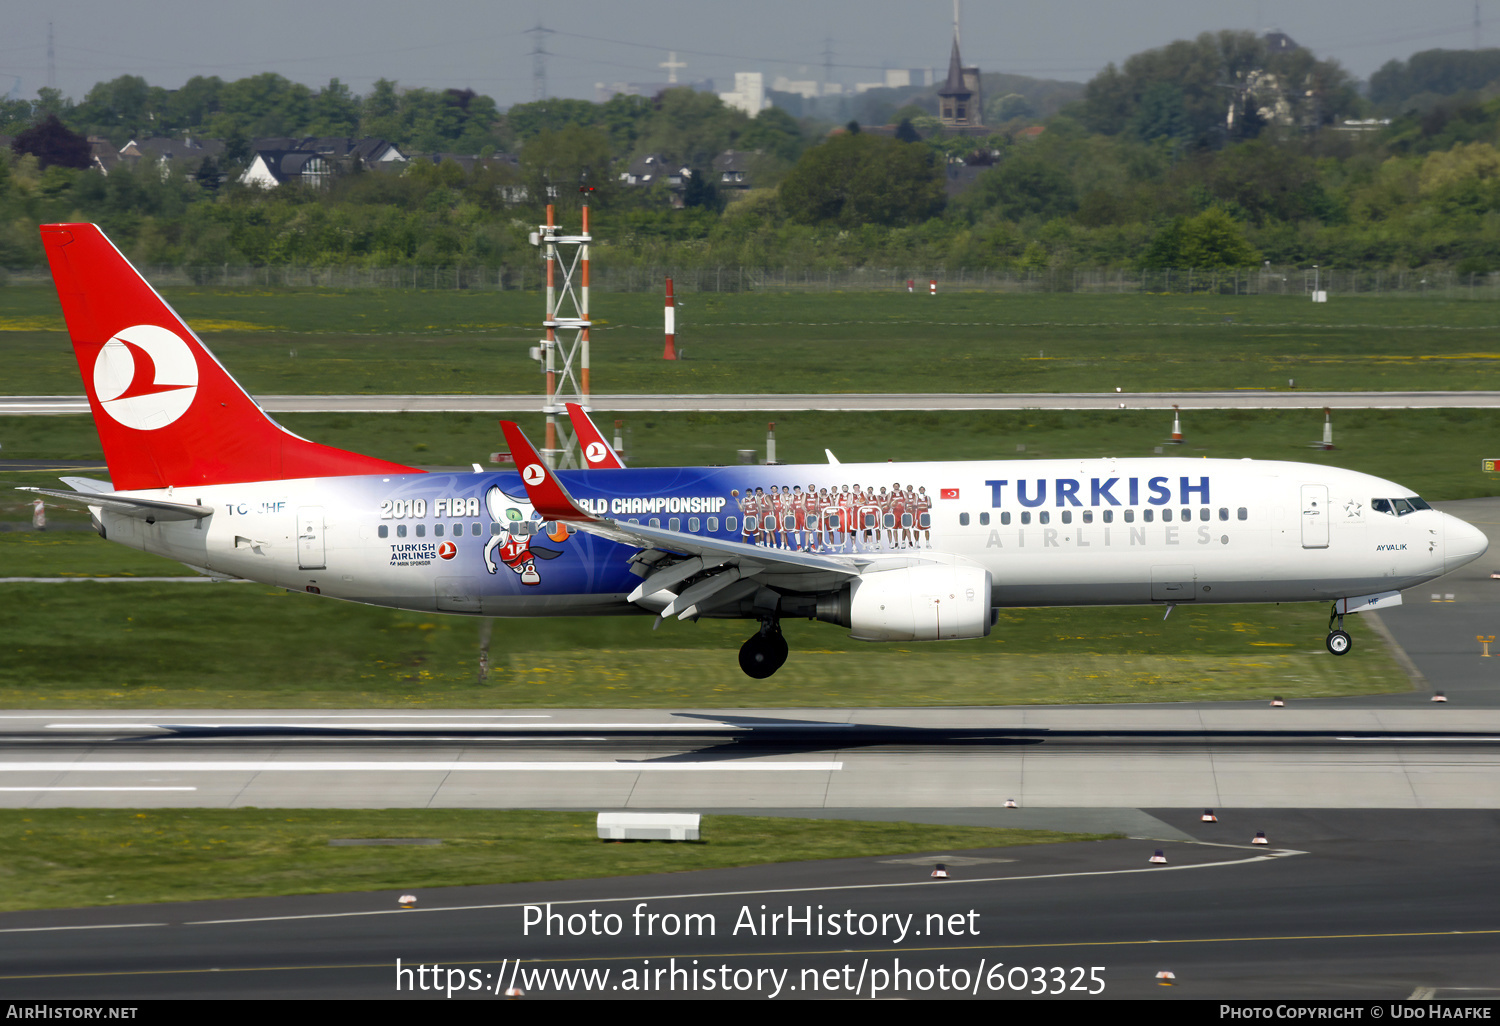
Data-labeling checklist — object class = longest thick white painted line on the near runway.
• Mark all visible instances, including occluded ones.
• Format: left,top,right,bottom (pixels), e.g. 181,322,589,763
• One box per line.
0,759,843,773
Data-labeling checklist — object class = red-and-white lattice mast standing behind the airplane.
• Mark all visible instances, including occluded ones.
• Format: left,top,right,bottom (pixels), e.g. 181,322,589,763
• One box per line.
533,198,593,470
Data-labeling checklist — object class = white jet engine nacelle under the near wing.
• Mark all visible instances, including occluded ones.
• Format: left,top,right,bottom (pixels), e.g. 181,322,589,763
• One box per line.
818,566,990,641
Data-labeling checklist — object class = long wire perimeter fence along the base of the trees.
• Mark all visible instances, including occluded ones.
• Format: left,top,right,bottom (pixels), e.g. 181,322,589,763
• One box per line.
0,260,1500,300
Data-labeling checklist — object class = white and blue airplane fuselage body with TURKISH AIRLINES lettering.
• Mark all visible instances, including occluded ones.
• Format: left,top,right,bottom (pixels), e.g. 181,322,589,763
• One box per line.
98,458,1487,617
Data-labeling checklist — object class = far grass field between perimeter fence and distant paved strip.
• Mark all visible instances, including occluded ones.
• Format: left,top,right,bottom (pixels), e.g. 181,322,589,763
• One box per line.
0,288,1500,395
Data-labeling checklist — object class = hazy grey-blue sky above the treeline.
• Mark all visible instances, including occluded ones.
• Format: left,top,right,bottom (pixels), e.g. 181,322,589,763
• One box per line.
0,0,1500,107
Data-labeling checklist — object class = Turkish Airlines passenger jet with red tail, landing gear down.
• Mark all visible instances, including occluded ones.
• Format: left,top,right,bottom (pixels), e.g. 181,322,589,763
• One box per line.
20,224,1488,678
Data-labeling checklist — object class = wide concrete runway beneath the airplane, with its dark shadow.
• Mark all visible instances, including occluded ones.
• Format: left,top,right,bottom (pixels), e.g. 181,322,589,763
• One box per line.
0,707,1500,822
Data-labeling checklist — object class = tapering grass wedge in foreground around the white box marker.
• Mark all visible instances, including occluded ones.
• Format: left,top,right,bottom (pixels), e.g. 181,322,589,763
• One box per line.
0,809,1100,912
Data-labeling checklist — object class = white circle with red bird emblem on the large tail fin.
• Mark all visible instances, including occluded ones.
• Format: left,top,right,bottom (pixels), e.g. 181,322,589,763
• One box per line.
95,324,198,431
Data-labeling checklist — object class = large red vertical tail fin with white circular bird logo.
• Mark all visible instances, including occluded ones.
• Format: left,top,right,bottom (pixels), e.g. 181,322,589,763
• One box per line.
42,225,419,491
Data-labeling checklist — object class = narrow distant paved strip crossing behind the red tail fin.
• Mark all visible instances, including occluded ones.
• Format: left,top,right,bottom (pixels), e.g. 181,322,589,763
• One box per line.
0,389,1500,416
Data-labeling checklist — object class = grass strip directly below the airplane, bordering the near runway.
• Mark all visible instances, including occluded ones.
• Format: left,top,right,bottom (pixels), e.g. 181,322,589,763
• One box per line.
0,546,1410,708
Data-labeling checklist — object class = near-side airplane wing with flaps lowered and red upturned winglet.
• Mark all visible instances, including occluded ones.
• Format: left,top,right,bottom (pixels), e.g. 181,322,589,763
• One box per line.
500,420,936,620
